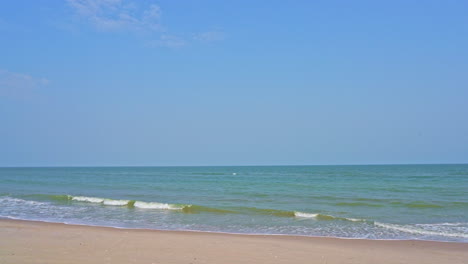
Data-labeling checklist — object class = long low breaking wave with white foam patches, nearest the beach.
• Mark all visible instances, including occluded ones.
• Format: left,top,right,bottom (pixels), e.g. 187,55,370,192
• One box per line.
0,195,468,240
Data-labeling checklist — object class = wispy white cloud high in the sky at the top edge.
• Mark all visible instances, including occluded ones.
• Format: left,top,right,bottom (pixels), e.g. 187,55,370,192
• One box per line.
67,0,163,31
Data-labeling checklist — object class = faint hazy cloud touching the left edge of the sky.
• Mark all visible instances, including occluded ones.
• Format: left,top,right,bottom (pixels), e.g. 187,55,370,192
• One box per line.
0,69,49,96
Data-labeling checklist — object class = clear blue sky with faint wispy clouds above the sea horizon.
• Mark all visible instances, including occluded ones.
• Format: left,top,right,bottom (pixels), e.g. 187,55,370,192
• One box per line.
0,0,468,166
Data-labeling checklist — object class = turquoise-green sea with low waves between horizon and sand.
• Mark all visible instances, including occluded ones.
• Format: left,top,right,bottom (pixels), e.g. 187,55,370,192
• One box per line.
0,165,468,242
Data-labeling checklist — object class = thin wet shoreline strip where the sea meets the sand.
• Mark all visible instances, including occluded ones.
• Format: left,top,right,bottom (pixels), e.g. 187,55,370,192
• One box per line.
0,217,468,245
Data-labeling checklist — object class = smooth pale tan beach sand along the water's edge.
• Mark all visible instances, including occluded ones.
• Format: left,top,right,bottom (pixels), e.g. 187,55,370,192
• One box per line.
0,220,468,264
